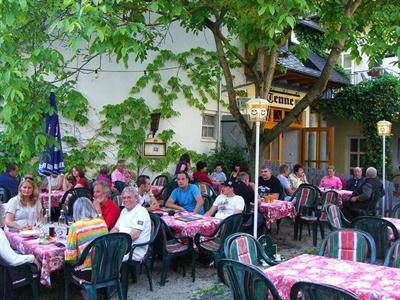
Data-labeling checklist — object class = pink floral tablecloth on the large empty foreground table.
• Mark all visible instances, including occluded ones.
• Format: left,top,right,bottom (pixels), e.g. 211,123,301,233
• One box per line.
264,254,400,300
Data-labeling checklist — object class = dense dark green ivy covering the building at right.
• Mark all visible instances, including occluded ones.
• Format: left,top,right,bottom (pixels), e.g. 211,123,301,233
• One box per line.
314,76,400,176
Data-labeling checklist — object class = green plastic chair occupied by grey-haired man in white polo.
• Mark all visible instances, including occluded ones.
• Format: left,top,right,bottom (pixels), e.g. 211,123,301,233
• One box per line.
128,213,161,291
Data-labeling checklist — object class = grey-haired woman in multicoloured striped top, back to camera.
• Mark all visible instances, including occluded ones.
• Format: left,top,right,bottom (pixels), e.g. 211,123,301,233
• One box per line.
65,197,108,281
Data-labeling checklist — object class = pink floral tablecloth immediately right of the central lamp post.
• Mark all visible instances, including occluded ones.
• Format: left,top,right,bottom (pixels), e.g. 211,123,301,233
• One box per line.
259,200,296,228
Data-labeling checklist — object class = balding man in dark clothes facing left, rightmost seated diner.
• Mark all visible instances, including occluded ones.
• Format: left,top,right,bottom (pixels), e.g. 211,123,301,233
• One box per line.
343,167,383,220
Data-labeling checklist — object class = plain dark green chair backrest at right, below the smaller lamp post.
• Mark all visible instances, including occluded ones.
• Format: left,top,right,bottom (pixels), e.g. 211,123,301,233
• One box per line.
351,216,399,259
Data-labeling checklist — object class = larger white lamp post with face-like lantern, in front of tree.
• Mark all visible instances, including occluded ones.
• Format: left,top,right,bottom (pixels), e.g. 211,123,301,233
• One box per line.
246,98,269,238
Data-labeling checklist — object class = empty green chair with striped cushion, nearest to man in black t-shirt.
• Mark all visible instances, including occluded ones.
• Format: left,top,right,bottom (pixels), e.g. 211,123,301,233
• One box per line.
292,184,324,247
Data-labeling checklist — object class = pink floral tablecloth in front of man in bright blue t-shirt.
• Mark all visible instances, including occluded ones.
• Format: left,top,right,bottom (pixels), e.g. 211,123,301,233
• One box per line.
161,212,221,238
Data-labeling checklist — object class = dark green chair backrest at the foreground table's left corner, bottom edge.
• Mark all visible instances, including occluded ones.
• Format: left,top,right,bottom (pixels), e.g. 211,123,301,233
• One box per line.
218,259,281,300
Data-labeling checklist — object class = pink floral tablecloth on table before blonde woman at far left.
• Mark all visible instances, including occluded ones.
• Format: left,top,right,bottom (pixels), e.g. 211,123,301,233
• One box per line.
5,231,65,287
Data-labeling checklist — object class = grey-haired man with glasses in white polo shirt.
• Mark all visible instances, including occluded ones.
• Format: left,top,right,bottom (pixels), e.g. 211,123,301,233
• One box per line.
111,186,151,261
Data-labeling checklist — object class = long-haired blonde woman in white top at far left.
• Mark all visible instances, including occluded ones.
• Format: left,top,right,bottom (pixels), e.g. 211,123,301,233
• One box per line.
6,177,43,230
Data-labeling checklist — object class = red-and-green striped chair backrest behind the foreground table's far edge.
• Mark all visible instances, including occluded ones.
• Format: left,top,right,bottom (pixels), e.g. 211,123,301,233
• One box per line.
319,229,376,263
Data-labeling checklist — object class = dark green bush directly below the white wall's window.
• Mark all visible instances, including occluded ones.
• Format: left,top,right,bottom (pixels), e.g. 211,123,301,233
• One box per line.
205,143,247,176
